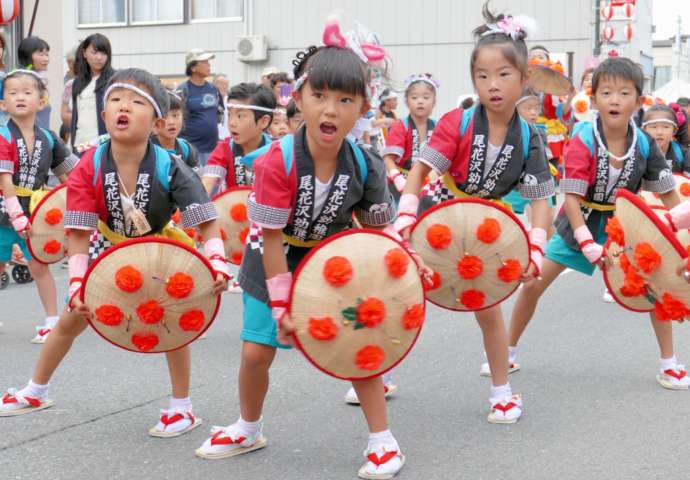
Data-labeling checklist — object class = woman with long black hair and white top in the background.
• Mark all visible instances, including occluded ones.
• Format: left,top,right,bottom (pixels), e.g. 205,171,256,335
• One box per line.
61,33,115,150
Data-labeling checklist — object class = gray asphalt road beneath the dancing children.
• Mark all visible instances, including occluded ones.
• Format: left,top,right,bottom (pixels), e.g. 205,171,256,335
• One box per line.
0,269,690,480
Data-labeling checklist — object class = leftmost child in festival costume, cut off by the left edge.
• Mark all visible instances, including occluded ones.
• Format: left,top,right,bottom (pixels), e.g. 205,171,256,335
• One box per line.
0,70,77,343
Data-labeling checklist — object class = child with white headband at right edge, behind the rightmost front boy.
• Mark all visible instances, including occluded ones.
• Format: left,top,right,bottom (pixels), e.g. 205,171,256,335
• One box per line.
642,104,690,175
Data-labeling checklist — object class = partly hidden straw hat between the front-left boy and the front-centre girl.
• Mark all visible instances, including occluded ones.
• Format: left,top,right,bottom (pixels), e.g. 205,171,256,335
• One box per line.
213,187,252,265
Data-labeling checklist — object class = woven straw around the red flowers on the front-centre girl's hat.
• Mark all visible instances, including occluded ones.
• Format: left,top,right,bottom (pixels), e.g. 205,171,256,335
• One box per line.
290,230,425,380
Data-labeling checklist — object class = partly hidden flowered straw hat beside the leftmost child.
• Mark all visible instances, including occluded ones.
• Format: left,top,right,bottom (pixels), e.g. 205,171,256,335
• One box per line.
26,185,67,264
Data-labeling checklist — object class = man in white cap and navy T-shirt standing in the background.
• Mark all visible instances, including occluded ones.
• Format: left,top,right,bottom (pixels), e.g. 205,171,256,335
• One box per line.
178,48,224,165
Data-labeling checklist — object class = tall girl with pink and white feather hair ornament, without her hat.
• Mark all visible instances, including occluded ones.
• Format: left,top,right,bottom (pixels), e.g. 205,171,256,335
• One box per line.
395,4,554,423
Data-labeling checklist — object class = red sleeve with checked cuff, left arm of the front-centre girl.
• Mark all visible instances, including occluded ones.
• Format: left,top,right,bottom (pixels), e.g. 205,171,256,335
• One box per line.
247,142,294,230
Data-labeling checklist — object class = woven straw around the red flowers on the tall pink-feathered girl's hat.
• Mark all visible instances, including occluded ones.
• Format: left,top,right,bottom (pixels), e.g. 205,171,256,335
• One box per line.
410,198,530,311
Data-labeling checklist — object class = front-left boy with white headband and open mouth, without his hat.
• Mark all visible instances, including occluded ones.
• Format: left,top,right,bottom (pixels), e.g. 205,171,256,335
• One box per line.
0,68,228,437
